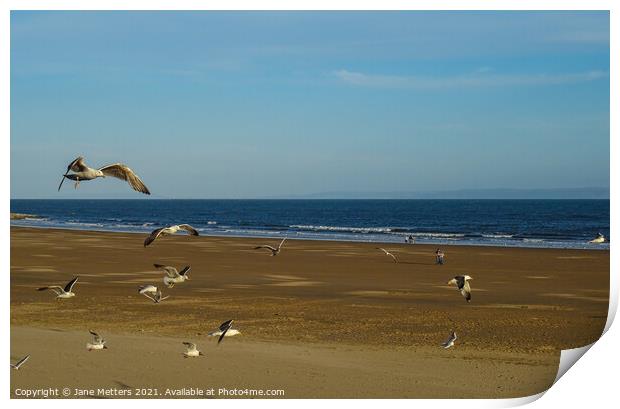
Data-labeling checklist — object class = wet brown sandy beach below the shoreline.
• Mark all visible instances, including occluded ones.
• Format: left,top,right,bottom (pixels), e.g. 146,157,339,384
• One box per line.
11,227,609,398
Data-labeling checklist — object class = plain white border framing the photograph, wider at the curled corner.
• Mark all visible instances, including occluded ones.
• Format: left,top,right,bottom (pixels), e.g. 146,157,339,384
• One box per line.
0,0,620,408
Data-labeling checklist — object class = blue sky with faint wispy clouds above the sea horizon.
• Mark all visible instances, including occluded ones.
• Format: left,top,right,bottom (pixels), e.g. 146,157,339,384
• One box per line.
11,11,609,198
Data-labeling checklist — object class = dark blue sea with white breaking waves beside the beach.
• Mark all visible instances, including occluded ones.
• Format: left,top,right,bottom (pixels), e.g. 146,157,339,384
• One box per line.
11,199,610,249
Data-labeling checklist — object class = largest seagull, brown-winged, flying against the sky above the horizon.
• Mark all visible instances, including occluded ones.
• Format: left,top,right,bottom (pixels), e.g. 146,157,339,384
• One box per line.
58,156,151,195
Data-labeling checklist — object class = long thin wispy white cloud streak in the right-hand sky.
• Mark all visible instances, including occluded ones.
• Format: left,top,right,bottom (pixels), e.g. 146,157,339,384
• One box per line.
333,70,608,89
